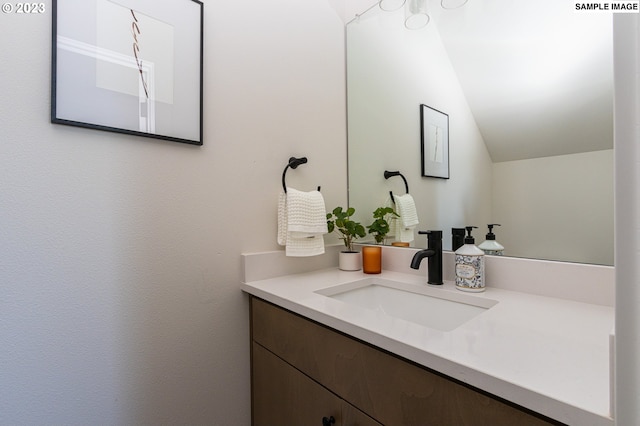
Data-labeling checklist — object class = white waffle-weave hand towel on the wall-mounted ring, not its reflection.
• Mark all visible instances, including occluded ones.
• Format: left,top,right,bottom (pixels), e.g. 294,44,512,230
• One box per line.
278,188,328,257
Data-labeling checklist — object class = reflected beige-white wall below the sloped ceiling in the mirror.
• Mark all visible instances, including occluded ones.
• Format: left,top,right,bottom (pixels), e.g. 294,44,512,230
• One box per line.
490,150,614,265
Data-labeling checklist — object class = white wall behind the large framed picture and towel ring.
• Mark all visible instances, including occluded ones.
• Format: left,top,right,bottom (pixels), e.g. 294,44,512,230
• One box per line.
0,0,346,425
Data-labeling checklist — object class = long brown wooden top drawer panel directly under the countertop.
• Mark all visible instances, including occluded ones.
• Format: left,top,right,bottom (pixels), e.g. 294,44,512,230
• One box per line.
251,297,560,426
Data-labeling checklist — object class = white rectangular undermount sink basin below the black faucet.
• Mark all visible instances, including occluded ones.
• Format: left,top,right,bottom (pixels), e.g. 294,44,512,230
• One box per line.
316,278,498,331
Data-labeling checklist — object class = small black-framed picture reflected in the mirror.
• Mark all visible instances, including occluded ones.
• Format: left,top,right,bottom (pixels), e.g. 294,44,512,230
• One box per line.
420,104,449,179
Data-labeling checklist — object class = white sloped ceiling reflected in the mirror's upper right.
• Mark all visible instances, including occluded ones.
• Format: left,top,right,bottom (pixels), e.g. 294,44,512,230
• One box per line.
429,0,613,162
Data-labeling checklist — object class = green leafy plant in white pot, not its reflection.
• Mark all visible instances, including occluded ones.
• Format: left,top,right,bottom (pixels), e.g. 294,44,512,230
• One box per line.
327,207,367,271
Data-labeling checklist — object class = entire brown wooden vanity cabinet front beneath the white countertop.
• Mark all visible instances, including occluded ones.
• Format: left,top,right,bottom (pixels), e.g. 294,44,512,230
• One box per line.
251,296,561,426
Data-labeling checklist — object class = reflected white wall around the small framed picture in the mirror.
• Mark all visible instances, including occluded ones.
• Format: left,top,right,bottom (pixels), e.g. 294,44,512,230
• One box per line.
347,7,493,249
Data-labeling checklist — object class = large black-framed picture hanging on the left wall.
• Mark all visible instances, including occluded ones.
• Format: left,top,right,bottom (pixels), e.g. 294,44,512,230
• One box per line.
51,0,203,145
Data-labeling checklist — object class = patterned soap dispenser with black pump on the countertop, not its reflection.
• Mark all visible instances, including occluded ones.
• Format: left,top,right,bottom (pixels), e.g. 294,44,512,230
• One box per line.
455,226,485,292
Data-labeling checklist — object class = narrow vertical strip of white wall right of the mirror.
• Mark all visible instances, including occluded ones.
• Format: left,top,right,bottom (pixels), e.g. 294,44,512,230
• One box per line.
613,10,640,426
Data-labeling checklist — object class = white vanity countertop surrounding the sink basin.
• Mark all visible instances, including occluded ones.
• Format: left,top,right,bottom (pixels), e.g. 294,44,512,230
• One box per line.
242,268,614,426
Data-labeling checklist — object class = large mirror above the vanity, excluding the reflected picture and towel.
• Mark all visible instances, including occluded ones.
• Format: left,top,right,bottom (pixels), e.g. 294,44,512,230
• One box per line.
347,0,614,265
